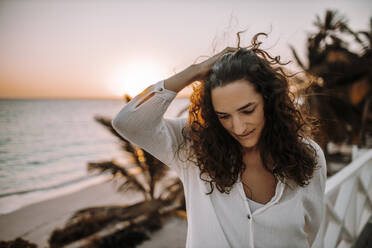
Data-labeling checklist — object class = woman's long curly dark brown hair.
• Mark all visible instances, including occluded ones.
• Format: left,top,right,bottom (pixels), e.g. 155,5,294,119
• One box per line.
178,32,317,194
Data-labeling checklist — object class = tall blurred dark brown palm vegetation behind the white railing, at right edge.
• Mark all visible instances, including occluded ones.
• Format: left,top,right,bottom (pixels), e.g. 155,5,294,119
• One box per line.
291,10,372,162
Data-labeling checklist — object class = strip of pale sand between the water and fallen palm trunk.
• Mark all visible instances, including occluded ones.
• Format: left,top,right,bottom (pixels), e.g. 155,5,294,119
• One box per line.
0,181,142,247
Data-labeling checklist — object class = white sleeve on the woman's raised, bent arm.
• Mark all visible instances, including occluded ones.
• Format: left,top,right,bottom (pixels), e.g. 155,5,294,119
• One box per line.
111,80,186,176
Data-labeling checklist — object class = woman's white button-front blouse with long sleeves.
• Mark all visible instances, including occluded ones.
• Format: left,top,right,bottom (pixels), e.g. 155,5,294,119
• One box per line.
112,81,326,248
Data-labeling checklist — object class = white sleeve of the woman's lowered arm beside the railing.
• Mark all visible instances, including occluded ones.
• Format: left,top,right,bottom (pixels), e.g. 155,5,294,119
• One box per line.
304,141,327,248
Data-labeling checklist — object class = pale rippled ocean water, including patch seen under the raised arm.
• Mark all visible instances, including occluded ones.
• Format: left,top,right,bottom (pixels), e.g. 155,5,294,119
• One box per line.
0,98,189,215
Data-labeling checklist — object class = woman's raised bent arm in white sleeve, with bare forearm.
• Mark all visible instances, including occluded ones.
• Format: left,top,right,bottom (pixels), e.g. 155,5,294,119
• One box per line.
111,48,237,175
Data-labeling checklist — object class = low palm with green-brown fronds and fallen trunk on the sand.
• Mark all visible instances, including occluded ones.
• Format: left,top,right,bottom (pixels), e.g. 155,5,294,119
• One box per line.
49,95,186,247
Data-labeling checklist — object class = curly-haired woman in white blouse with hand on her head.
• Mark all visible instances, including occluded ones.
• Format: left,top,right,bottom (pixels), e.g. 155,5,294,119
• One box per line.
112,34,326,248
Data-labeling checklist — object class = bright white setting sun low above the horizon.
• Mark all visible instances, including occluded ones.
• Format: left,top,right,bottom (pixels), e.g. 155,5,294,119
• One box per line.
108,62,166,97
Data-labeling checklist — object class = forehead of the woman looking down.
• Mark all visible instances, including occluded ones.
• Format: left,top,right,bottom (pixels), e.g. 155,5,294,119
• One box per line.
211,79,263,113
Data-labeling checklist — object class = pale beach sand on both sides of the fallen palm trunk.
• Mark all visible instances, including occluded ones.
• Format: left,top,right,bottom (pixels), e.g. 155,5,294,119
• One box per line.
0,182,187,248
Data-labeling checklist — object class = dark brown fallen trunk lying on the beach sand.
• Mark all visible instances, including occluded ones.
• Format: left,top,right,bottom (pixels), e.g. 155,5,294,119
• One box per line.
50,200,182,248
